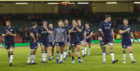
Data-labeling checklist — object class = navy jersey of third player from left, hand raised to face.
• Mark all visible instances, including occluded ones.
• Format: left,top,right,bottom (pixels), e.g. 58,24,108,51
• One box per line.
38,26,49,40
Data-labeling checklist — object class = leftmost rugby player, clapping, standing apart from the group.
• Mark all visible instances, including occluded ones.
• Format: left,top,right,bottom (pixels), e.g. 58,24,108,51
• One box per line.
2,20,16,66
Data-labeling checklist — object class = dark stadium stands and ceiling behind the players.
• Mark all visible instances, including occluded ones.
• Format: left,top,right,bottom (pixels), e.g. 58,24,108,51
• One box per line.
0,0,140,43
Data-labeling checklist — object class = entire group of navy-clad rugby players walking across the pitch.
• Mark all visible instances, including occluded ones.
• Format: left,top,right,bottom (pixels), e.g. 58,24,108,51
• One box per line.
2,15,136,66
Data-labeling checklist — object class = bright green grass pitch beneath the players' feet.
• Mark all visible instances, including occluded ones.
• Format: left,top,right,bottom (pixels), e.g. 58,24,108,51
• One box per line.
0,43,140,71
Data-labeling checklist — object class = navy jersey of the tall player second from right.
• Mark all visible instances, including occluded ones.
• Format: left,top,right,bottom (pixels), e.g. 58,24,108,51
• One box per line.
99,21,113,38
